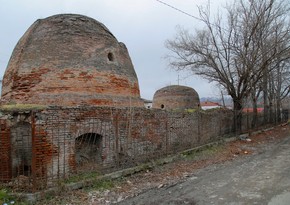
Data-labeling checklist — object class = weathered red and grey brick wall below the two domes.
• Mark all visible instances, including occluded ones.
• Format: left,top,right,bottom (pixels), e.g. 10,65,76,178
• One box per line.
1,107,231,187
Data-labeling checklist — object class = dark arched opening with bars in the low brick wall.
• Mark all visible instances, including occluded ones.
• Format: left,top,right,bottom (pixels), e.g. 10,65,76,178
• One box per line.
75,133,103,166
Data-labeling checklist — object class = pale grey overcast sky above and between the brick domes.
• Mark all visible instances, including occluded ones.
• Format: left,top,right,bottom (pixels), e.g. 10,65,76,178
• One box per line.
0,0,231,99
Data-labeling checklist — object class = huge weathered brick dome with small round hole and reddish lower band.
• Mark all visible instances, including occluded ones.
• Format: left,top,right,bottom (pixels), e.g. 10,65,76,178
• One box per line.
2,14,143,107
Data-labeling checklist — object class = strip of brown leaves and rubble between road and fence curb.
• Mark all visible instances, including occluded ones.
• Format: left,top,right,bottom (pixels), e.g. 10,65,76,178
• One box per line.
39,125,290,205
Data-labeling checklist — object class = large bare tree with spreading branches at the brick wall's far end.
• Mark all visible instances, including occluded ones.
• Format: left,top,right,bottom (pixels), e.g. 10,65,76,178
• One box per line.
166,0,290,131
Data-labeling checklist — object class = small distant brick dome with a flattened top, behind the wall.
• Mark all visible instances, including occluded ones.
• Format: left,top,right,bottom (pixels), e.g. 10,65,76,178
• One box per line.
153,85,200,110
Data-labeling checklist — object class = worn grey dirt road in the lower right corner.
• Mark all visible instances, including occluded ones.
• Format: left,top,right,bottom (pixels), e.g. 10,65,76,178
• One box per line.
119,127,290,205
